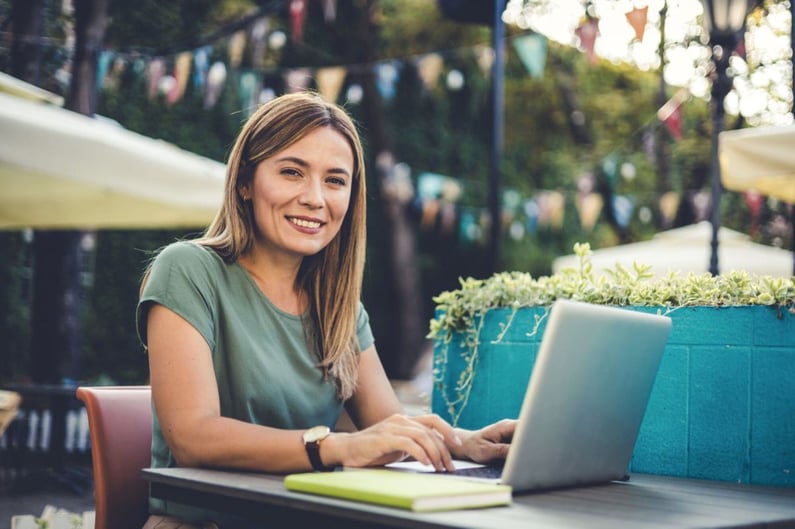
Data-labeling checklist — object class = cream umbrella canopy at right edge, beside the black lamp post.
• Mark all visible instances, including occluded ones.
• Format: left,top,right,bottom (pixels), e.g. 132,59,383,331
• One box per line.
718,125,795,204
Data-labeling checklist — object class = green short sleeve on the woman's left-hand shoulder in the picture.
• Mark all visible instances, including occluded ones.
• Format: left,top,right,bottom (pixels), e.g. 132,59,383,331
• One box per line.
136,241,220,349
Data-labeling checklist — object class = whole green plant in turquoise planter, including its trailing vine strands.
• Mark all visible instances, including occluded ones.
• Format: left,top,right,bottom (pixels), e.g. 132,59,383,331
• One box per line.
428,243,795,425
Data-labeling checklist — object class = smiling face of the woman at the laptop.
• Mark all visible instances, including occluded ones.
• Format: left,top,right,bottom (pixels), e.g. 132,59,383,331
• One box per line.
239,127,354,257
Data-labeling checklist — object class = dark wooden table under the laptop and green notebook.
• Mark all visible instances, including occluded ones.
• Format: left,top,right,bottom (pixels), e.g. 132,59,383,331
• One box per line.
142,468,795,529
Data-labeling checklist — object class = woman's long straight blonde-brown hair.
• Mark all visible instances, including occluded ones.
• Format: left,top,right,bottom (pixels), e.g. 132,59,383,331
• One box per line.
144,92,366,400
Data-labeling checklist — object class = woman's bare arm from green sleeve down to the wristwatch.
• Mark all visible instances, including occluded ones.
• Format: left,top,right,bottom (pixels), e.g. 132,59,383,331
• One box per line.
147,304,311,472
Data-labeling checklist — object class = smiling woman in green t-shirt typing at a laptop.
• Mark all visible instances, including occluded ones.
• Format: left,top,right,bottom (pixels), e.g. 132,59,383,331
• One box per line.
137,93,514,528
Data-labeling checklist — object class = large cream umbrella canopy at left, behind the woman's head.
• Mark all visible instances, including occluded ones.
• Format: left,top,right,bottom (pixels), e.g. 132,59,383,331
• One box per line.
0,89,225,229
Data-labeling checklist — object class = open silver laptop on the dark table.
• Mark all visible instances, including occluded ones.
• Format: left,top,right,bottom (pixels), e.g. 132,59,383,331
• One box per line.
388,299,671,492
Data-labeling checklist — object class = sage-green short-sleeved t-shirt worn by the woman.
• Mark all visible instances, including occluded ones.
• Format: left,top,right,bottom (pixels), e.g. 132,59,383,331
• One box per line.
136,241,374,514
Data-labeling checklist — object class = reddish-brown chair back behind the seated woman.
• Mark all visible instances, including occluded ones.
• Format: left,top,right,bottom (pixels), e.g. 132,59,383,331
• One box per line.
76,386,152,529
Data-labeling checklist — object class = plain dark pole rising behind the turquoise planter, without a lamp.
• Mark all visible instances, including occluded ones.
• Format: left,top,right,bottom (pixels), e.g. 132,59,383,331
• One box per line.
489,0,505,274
